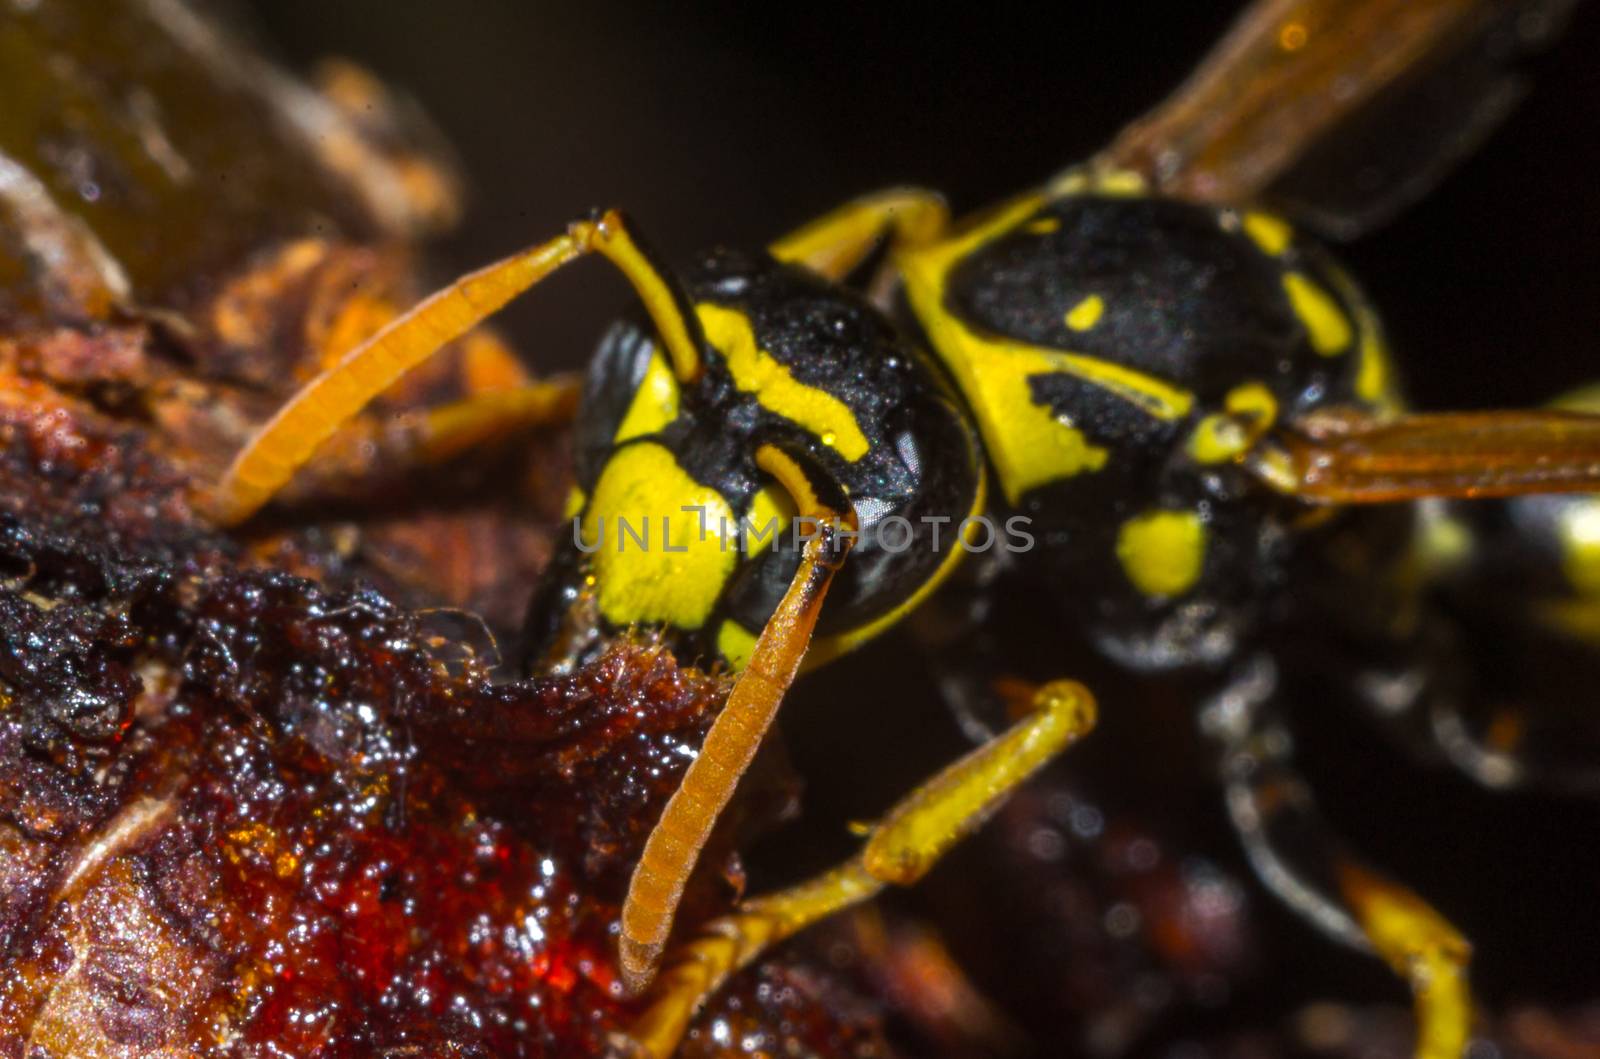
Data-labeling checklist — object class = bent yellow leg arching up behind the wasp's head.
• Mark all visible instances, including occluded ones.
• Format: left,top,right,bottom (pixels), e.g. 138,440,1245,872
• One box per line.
766,187,950,280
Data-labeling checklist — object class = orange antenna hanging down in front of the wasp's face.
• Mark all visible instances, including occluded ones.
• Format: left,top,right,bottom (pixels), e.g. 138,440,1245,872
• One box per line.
618,446,856,993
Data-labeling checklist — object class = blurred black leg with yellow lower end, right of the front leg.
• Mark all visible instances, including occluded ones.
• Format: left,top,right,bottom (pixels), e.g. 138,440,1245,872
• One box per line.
1203,657,1472,1059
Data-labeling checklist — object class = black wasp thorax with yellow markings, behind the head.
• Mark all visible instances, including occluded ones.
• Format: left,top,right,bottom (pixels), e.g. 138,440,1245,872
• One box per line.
904,176,1390,665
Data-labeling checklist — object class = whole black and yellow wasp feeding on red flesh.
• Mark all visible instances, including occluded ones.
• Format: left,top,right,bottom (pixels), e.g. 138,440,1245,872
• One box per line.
211,0,1600,1057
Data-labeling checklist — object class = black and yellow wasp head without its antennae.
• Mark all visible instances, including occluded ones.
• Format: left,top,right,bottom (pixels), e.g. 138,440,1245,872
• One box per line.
538,244,984,664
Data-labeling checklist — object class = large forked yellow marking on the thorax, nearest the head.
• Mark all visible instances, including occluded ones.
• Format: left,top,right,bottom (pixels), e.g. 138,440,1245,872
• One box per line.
896,192,1194,504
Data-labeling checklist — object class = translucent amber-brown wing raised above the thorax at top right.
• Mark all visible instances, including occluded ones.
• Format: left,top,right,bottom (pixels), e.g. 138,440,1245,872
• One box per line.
1101,0,1576,238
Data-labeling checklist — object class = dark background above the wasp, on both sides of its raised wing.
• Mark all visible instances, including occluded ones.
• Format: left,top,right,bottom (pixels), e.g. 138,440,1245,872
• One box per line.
246,0,1600,405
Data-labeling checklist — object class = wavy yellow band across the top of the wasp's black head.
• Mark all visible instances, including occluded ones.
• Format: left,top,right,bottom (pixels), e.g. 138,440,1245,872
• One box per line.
694,302,867,461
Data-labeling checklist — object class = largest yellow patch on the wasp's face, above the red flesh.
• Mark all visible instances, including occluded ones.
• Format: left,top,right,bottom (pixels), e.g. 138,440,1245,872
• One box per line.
581,442,739,629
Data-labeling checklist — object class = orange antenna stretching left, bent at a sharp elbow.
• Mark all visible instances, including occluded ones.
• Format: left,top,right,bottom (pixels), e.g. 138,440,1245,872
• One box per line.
211,210,699,525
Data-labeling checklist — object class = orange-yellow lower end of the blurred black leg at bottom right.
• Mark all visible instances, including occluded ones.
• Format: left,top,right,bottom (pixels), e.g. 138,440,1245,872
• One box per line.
1339,864,1472,1059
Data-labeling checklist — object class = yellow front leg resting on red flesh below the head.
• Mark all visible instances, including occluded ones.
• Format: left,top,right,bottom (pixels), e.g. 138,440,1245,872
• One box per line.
617,680,1096,1059
